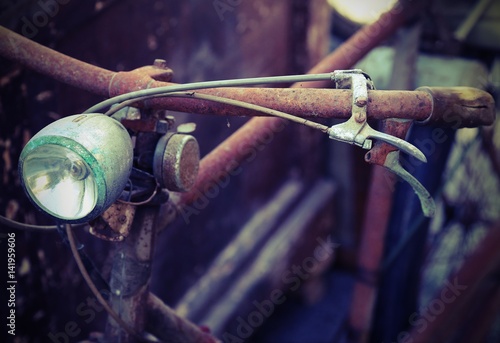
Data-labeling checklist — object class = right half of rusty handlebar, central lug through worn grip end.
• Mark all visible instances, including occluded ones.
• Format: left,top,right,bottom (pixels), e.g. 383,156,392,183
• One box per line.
109,68,495,128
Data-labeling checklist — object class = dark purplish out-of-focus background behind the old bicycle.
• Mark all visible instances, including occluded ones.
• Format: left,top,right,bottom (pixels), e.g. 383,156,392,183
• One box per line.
0,0,500,343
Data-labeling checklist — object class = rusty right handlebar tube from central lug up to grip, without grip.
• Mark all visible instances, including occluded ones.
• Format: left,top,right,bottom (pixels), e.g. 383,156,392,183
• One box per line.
110,71,433,121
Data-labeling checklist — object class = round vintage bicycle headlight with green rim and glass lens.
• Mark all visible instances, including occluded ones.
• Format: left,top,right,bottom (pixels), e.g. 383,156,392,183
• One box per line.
19,113,133,223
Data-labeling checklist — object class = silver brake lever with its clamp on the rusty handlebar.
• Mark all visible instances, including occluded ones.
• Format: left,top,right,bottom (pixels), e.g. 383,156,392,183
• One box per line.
327,69,435,217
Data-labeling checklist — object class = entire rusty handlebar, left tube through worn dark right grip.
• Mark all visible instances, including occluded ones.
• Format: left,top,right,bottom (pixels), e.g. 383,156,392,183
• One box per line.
0,26,495,128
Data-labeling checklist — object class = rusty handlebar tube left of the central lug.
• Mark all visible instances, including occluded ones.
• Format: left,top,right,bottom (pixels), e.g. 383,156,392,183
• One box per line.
0,26,116,96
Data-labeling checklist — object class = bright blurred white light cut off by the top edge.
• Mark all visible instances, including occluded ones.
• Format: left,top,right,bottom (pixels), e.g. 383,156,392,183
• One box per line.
328,0,397,25
